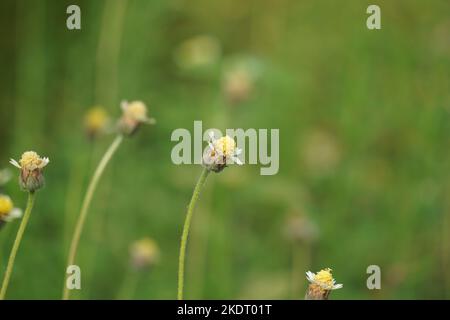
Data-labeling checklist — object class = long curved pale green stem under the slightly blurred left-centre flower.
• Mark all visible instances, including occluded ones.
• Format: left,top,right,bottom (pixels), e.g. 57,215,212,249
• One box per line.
63,135,123,300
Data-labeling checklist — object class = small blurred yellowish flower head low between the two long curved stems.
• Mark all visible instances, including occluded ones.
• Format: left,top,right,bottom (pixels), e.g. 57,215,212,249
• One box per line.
130,238,159,270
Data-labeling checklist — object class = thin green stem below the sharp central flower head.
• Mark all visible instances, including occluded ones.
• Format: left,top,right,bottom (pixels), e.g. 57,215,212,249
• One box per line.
178,168,210,300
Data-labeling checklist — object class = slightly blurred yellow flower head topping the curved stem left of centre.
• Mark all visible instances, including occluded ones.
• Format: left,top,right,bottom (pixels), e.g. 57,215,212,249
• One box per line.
119,101,156,136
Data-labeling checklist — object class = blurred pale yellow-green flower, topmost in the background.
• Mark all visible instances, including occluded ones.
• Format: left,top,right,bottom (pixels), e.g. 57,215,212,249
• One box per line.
175,35,221,69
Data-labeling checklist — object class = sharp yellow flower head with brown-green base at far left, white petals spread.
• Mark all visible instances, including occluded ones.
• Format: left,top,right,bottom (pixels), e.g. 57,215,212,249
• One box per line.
10,151,49,192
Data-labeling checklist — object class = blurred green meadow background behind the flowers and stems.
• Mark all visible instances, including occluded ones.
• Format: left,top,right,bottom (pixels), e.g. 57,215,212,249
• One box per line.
0,0,450,299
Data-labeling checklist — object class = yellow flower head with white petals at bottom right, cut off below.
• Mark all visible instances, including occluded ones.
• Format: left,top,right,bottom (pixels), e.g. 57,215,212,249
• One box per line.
305,268,343,300
